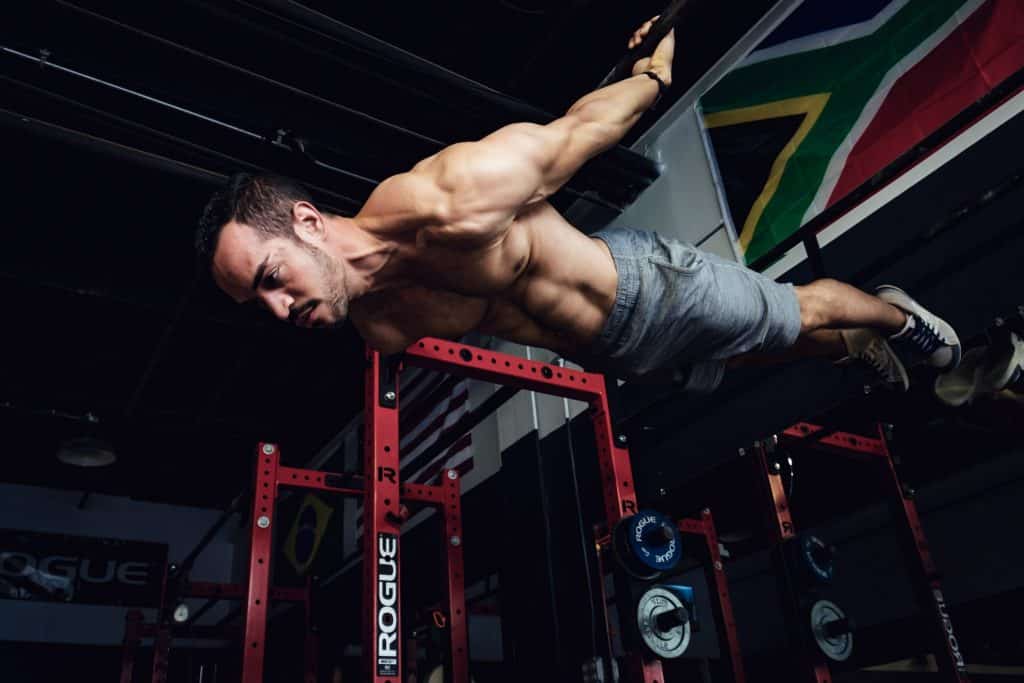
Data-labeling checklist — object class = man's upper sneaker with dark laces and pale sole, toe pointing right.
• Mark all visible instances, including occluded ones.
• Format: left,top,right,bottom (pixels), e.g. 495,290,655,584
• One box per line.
874,285,961,370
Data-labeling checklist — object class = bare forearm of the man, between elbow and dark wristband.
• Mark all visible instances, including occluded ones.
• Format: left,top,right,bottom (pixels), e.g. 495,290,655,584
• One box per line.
565,74,658,151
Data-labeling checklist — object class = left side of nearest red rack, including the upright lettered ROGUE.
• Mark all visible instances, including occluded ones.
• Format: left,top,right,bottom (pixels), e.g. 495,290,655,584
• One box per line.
242,351,469,683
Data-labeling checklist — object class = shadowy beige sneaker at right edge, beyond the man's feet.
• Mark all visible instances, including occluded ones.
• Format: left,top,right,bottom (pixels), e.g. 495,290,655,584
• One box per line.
935,331,1024,408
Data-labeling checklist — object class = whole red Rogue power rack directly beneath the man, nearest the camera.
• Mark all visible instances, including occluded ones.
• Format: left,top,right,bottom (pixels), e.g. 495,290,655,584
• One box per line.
146,338,742,683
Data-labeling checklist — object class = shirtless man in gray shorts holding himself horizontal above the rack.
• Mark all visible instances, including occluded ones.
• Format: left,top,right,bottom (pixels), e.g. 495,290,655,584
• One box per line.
197,22,959,391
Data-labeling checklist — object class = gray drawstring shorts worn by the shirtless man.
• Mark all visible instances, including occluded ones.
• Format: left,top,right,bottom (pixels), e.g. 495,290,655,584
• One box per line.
587,229,800,392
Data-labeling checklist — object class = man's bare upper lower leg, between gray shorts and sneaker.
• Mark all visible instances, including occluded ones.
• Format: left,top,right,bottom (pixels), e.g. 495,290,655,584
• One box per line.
796,280,906,335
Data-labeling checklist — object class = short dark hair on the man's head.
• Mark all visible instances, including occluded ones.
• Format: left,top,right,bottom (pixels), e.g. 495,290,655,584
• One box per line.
196,173,312,269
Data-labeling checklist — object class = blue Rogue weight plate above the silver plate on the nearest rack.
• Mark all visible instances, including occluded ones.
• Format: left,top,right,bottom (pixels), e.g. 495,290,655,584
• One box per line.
612,510,682,580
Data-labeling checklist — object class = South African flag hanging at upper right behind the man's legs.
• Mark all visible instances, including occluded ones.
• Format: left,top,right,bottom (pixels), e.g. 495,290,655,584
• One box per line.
700,0,1024,263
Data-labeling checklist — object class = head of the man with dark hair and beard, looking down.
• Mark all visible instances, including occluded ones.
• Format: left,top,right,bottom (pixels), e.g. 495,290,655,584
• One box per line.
196,173,348,327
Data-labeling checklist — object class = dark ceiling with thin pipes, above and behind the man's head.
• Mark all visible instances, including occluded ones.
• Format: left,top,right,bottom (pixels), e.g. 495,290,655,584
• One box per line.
0,0,773,506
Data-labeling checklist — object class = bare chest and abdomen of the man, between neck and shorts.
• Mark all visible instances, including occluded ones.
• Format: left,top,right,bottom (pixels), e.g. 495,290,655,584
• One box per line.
349,202,617,353
